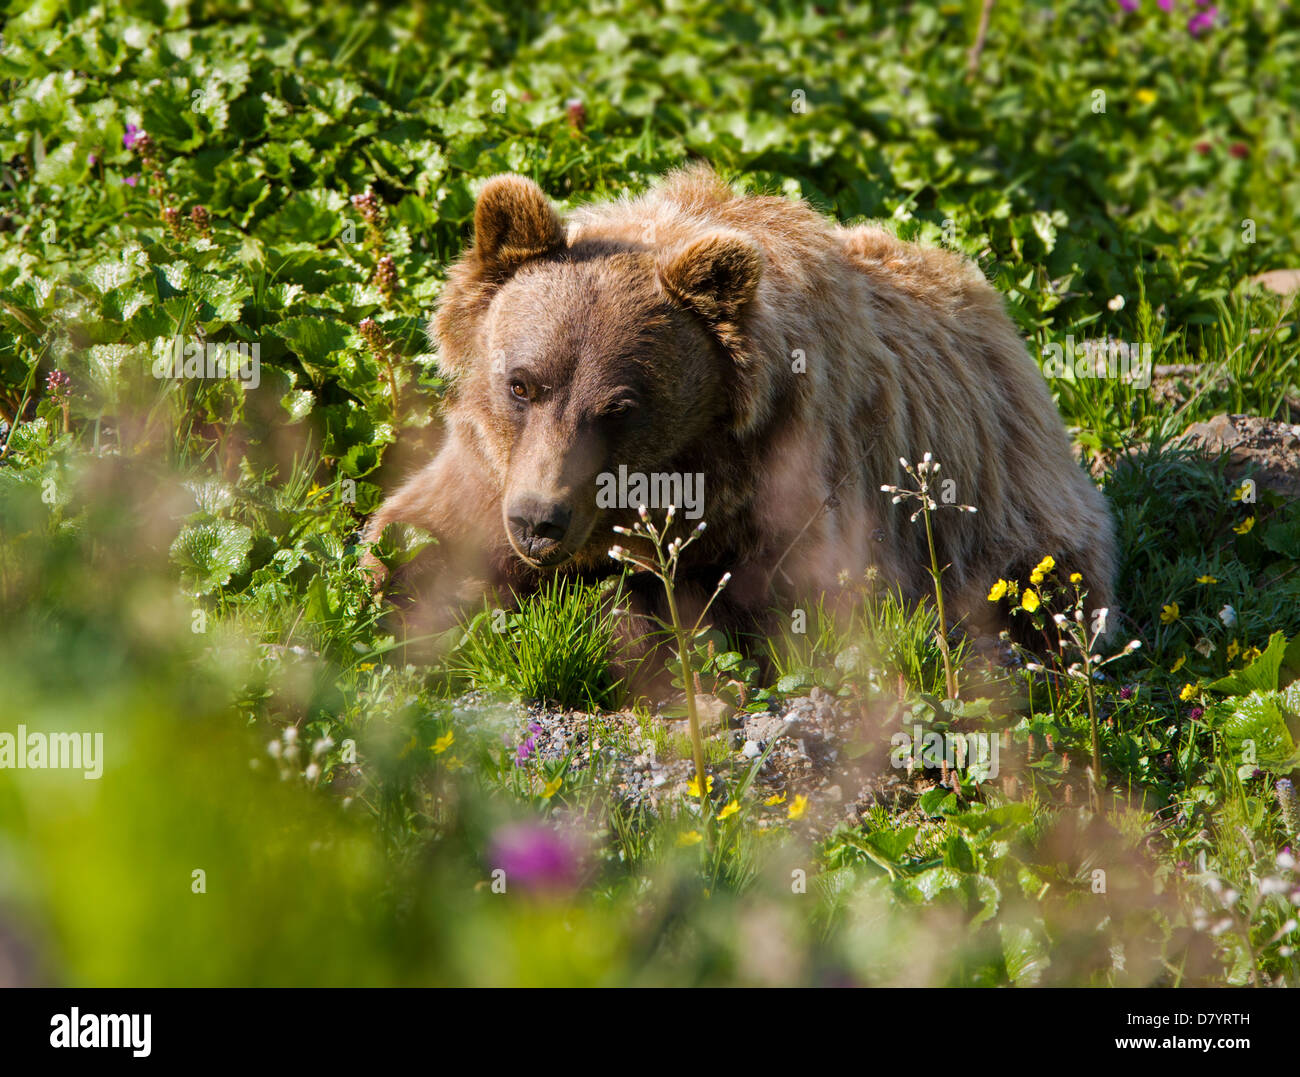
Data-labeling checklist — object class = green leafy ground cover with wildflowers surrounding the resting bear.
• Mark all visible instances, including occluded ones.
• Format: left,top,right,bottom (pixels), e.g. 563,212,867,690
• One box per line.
0,0,1300,985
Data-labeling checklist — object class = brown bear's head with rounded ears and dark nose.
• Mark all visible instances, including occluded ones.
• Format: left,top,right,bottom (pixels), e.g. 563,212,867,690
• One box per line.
434,176,763,568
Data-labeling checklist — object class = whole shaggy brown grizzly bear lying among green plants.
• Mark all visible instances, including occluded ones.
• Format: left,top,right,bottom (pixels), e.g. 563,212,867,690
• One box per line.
365,166,1114,671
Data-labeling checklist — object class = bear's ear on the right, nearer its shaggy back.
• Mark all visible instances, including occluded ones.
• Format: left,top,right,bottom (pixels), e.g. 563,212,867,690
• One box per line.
658,232,763,341
